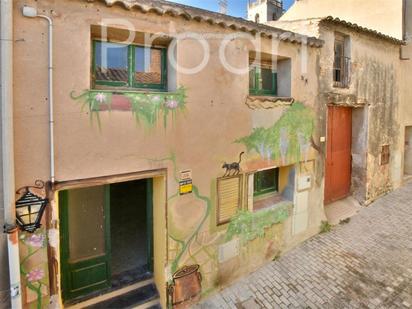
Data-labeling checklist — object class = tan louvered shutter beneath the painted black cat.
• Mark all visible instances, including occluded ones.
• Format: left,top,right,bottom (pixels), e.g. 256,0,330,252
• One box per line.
216,175,242,225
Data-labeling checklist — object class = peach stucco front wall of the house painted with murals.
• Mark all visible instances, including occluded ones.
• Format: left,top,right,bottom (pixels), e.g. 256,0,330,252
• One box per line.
14,0,328,307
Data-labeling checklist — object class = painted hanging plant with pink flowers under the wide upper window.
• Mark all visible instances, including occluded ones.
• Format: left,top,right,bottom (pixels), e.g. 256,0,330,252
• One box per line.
70,87,187,128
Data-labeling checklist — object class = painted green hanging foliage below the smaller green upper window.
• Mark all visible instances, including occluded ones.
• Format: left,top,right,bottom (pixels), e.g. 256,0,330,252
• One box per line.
235,102,314,163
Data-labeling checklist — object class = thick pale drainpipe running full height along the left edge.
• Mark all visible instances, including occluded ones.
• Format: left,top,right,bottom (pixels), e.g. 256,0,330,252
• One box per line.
0,0,22,309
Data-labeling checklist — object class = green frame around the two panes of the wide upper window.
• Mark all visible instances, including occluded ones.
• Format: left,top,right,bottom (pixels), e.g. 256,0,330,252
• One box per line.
92,40,167,91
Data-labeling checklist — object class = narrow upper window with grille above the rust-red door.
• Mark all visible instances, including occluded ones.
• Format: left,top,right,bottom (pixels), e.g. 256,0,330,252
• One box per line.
333,34,350,87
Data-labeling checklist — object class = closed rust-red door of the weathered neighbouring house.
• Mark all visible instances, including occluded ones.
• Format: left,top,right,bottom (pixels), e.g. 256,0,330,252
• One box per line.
325,106,352,204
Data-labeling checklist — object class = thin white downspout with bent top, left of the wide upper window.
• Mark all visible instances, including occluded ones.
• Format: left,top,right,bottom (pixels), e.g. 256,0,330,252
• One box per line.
22,6,55,185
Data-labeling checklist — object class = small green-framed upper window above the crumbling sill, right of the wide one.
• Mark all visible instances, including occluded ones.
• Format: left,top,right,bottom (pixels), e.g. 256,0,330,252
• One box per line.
249,65,277,96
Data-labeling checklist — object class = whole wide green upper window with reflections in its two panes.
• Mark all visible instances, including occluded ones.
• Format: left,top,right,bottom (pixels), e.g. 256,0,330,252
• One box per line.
93,41,167,91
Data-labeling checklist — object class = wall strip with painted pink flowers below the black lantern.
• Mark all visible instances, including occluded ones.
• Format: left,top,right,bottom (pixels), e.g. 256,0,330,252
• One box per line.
19,228,49,309
